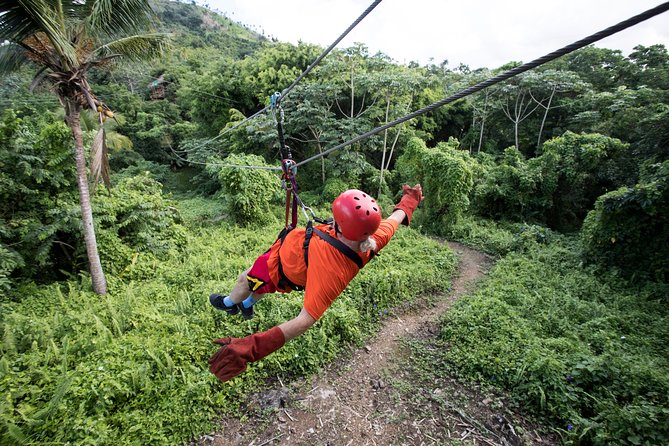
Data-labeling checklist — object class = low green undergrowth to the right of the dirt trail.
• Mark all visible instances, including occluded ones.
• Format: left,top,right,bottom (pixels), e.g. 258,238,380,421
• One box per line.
435,233,669,445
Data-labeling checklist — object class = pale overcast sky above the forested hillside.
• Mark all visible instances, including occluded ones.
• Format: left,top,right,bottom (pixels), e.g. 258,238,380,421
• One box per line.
198,0,669,69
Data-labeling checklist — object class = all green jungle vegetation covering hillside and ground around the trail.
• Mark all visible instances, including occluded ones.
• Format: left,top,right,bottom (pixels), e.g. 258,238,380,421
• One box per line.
0,0,669,445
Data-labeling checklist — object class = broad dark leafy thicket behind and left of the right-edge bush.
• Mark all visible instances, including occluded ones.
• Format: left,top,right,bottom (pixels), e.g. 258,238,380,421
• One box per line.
473,132,635,231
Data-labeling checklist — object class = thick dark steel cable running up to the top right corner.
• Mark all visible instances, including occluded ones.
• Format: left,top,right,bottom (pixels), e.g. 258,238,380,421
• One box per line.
296,2,669,167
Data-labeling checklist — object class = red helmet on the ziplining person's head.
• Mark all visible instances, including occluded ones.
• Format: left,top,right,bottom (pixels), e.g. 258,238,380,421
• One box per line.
332,189,381,242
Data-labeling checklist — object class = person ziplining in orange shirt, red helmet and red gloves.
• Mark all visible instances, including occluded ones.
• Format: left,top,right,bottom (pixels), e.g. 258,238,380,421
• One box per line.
209,184,423,381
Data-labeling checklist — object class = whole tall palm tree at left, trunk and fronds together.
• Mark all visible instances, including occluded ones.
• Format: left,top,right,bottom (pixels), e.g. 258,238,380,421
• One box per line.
0,0,169,294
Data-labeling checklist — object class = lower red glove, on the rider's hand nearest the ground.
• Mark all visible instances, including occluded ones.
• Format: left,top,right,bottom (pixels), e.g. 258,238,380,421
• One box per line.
209,326,286,381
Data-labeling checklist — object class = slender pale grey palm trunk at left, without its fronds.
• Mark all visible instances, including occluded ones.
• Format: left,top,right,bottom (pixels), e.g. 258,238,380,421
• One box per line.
65,99,107,294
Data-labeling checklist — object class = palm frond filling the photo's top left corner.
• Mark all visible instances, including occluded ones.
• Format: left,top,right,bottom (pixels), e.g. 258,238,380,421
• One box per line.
0,0,77,68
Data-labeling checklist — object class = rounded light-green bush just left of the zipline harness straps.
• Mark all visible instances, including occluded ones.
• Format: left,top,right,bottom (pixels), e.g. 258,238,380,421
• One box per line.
207,154,281,225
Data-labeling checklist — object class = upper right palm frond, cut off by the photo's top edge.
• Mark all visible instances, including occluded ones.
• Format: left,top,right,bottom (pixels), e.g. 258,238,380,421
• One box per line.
85,0,157,36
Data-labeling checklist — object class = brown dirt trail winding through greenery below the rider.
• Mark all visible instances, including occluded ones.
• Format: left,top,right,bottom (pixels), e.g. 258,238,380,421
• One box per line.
202,242,552,446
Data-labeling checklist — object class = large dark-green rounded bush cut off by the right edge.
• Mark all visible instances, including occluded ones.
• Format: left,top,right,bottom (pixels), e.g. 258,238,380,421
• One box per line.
582,161,669,282
